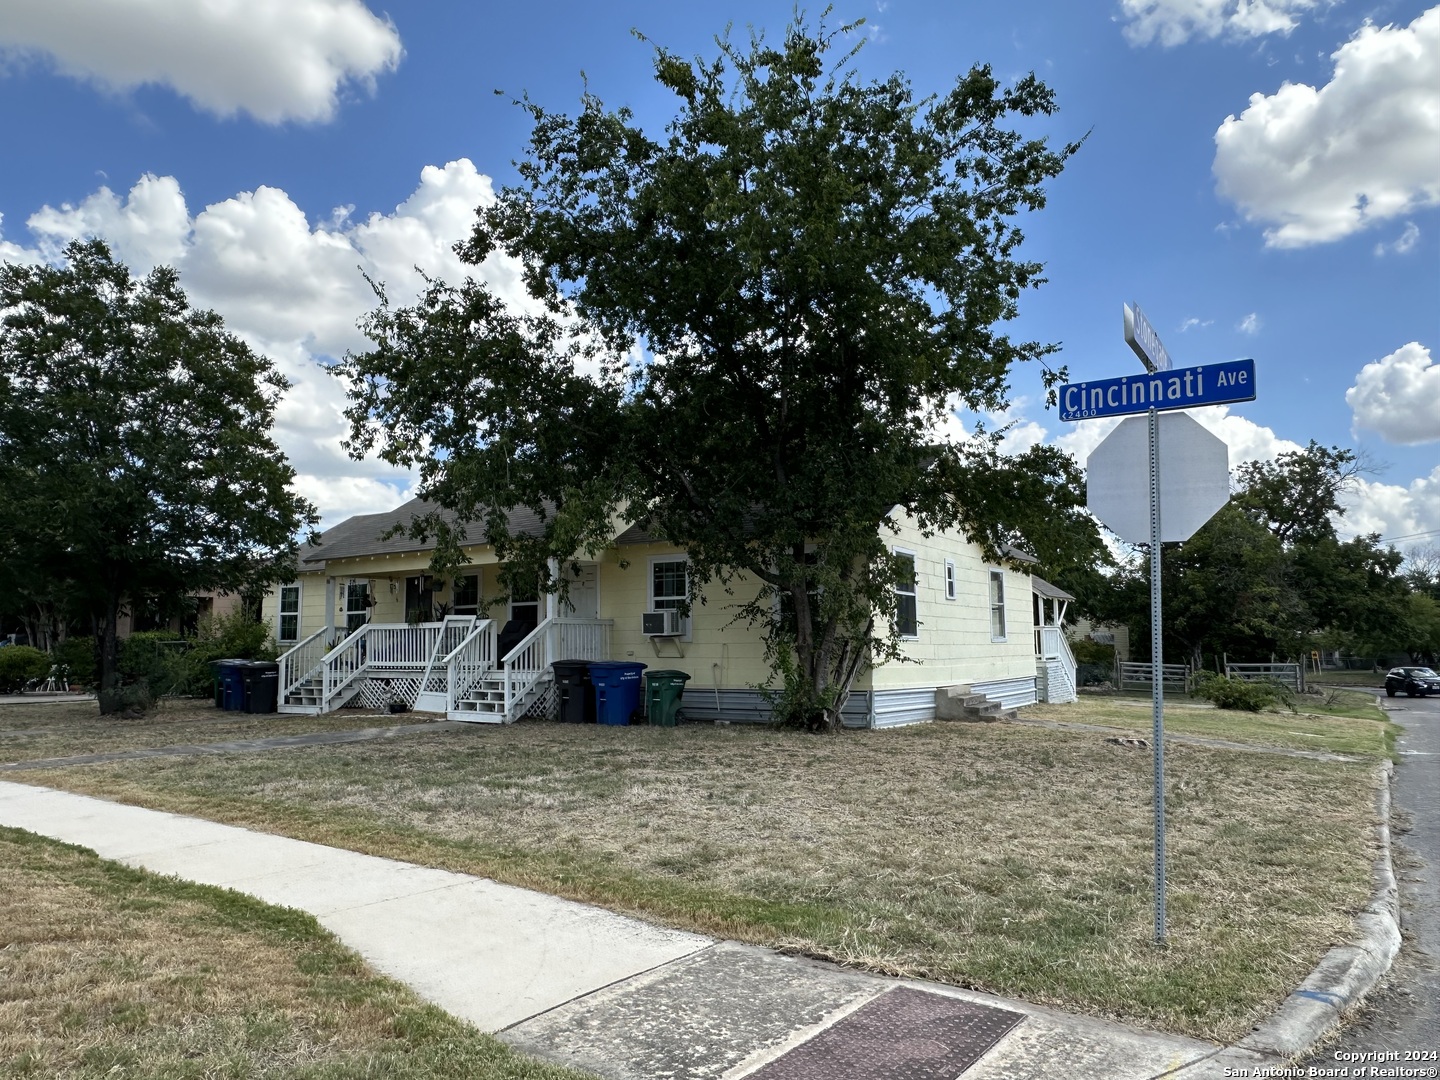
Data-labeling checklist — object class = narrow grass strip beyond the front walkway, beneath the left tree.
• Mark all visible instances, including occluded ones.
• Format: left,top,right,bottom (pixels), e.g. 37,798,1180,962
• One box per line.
0,698,428,765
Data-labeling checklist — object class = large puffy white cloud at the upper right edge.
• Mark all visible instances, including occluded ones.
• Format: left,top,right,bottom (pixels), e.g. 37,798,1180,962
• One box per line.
1214,7,1440,248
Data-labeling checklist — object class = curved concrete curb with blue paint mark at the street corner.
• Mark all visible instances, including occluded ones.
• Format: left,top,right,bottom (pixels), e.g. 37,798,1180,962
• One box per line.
1236,762,1400,1057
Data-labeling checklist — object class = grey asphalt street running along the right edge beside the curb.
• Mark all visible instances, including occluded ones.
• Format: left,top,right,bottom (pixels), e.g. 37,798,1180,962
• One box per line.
1300,691,1440,1076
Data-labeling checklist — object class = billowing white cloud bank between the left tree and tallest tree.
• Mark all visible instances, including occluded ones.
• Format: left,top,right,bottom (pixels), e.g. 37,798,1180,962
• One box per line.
11,158,524,526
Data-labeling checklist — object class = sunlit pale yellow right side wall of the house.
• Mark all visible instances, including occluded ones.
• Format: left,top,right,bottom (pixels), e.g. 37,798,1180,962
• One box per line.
868,517,1035,696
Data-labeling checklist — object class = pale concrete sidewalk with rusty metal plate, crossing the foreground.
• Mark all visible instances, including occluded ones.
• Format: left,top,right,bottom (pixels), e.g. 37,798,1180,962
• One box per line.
0,782,1307,1080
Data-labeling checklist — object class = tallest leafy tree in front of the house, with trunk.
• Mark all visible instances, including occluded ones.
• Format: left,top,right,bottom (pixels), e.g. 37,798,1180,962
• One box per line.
343,19,1083,726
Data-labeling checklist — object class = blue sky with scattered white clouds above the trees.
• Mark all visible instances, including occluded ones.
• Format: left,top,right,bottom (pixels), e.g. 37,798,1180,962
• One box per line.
0,0,1440,549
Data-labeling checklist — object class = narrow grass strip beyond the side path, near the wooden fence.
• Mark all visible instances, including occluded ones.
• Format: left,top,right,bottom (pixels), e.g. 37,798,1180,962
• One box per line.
1021,691,1397,759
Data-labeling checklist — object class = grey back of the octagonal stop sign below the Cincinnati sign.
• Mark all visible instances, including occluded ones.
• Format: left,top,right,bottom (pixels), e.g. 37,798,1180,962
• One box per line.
1086,412,1230,544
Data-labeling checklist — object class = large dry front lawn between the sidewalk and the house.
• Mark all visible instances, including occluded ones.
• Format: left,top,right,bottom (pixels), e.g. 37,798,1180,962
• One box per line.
7,710,1381,1041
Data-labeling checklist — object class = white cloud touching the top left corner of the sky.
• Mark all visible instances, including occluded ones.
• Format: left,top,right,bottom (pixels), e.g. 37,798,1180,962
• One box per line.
0,0,402,124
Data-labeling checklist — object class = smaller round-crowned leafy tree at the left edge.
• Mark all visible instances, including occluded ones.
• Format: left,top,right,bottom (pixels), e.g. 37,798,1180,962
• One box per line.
0,240,315,713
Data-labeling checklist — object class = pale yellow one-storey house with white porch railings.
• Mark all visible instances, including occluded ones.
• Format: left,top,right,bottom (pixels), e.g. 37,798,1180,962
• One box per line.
264,500,1073,727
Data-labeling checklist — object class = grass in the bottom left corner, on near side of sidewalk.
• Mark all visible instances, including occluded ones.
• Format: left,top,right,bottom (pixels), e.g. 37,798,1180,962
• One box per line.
0,828,596,1080
